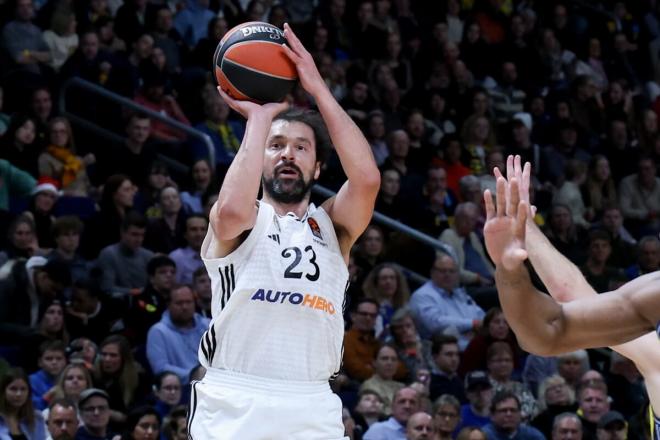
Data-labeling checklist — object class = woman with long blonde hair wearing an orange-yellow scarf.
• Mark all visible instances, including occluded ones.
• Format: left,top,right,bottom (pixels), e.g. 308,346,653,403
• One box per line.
39,117,96,197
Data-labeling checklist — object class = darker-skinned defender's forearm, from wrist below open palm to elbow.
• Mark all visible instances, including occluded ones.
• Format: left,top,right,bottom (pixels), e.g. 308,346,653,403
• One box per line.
495,265,563,356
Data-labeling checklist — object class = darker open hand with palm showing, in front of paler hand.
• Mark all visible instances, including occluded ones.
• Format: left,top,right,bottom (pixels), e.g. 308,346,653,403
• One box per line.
484,176,529,270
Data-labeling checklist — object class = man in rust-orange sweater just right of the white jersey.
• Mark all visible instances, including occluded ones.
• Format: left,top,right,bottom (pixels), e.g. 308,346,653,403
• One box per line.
343,298,380,382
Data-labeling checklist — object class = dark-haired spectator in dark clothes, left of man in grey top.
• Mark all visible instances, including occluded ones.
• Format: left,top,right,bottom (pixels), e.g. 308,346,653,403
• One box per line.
47,215,88,281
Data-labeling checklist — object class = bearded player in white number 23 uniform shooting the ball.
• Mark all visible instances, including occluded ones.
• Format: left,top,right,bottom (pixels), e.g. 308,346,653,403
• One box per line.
189,25,380,440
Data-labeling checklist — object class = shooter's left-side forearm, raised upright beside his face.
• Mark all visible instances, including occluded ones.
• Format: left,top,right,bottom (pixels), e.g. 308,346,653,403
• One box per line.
217,114,272,225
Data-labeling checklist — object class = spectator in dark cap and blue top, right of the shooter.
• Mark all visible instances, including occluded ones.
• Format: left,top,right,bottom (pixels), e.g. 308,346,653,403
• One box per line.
456,371,493,430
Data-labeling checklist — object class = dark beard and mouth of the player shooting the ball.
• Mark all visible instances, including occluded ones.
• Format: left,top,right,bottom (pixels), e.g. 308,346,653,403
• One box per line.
262,162,314,204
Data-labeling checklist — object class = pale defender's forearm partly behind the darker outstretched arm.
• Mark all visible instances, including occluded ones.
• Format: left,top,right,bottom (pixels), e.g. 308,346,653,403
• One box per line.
525,220,596,302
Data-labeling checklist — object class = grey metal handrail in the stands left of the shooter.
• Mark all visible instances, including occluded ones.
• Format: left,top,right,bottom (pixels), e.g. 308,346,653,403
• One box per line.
59,77,215,170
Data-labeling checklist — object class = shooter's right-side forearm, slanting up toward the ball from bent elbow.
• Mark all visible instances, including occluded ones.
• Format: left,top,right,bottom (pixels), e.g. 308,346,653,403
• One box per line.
314,87,380,186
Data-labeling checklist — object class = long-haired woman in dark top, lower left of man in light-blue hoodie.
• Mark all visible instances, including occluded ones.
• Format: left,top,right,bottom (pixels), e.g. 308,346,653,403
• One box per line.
93,335,150,426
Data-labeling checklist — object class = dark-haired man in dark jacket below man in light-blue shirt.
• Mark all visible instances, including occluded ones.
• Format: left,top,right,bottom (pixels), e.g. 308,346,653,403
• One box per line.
430,335,467,403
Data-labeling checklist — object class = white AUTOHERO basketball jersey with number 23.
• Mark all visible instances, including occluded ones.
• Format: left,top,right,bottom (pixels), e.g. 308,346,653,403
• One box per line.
199,201,348,381
